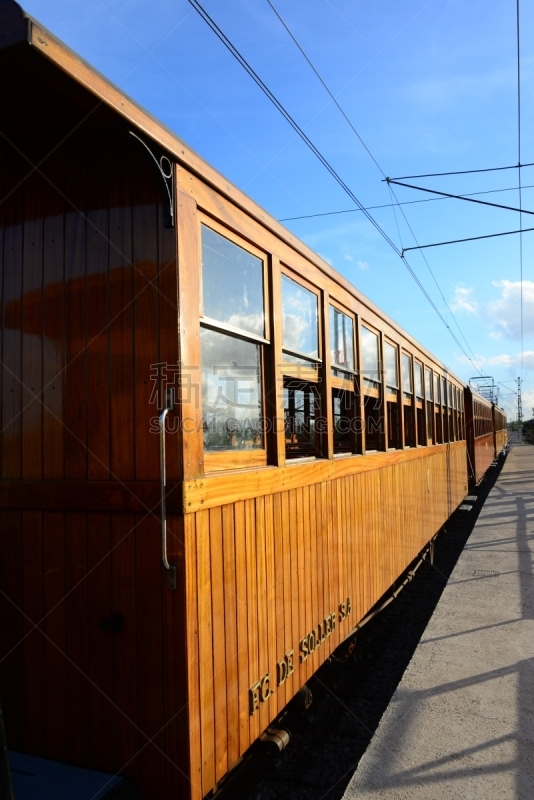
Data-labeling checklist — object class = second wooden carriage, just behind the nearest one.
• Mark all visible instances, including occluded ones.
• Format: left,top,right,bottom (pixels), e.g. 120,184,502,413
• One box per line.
465,387,497,488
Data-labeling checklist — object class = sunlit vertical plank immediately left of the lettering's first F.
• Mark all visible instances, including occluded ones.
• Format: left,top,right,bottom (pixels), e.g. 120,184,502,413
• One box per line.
234,500,250,755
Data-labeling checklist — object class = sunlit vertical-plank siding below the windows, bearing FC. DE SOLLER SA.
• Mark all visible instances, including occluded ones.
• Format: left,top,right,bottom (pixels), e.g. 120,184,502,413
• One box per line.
186,442,467,796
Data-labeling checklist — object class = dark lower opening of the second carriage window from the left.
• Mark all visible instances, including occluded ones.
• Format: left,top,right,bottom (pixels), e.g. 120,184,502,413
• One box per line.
284,377,320,459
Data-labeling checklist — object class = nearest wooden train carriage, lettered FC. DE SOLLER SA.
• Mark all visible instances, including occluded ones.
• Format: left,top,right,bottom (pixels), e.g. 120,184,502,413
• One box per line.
0,2,467,800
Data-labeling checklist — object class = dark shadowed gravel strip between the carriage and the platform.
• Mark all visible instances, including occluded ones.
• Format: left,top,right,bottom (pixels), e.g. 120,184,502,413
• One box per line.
230,456,506,800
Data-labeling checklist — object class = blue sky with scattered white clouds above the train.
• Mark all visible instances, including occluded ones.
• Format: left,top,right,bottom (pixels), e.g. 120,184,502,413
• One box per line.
23,0,534,417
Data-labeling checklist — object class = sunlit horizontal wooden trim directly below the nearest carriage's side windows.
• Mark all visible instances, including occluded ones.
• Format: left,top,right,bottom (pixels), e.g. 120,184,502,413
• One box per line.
183,442,465,514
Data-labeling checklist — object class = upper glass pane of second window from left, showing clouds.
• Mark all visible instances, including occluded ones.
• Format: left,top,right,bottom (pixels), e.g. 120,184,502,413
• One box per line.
282,275,319,358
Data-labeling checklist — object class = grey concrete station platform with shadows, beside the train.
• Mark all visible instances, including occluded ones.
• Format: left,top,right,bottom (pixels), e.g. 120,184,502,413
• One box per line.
344,445,534,800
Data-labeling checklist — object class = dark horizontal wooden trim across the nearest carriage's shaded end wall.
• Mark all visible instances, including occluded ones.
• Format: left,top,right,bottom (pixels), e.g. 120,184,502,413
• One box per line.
0,481,182,516
